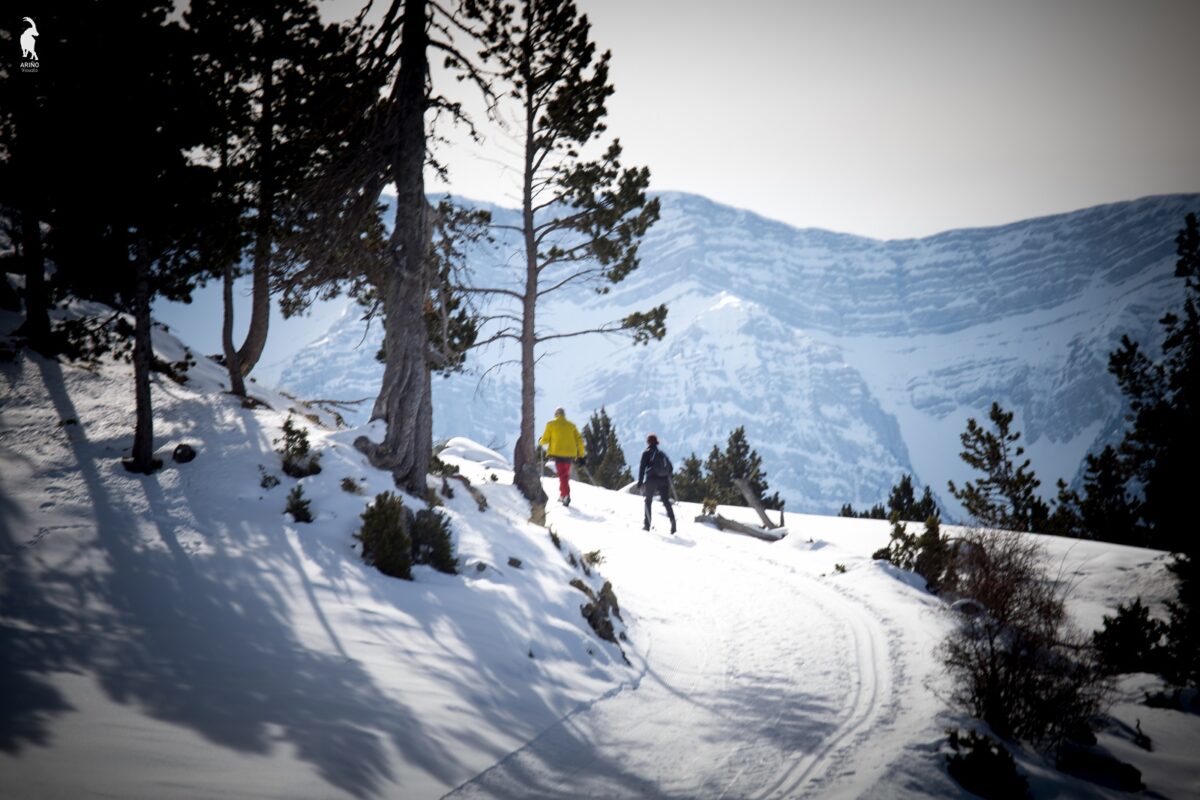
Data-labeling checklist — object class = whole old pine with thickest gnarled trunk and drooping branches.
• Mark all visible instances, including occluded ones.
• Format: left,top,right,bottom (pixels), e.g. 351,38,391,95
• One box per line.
326,0,490,494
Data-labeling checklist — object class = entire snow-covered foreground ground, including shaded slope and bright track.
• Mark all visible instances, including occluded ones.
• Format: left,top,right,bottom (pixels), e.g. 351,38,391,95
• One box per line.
0,308,1200,799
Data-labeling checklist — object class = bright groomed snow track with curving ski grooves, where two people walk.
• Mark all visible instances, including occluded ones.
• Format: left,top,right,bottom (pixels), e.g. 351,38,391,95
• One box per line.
446,486,930,799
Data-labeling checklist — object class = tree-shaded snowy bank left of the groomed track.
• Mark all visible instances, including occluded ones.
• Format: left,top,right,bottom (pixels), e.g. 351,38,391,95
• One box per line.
0,304,636,798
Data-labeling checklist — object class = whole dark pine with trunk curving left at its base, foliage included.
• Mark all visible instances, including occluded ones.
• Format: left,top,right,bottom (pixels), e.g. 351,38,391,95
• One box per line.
185,0,362,375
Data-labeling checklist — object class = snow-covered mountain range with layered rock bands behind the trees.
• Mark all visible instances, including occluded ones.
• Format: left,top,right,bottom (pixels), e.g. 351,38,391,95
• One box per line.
282,193,1200,516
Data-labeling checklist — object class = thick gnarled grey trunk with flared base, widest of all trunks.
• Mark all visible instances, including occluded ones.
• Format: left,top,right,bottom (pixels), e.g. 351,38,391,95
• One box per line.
354,0,433,497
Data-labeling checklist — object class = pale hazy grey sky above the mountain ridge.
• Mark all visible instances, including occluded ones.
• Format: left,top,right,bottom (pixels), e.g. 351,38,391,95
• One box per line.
364,0,1200,237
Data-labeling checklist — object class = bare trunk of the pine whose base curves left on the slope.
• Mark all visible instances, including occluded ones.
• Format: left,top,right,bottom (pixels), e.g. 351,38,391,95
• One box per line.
238,21,277,375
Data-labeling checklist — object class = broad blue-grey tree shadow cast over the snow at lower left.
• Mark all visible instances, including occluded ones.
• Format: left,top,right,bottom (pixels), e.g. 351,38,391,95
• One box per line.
0,361,455,798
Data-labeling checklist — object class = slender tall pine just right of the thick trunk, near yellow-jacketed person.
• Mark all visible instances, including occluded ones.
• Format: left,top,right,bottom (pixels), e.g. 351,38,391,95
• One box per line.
482,0,666,506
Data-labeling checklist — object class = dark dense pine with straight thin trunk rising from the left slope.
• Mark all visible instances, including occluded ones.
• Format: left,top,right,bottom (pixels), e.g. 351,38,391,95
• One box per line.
12,0,217,473
